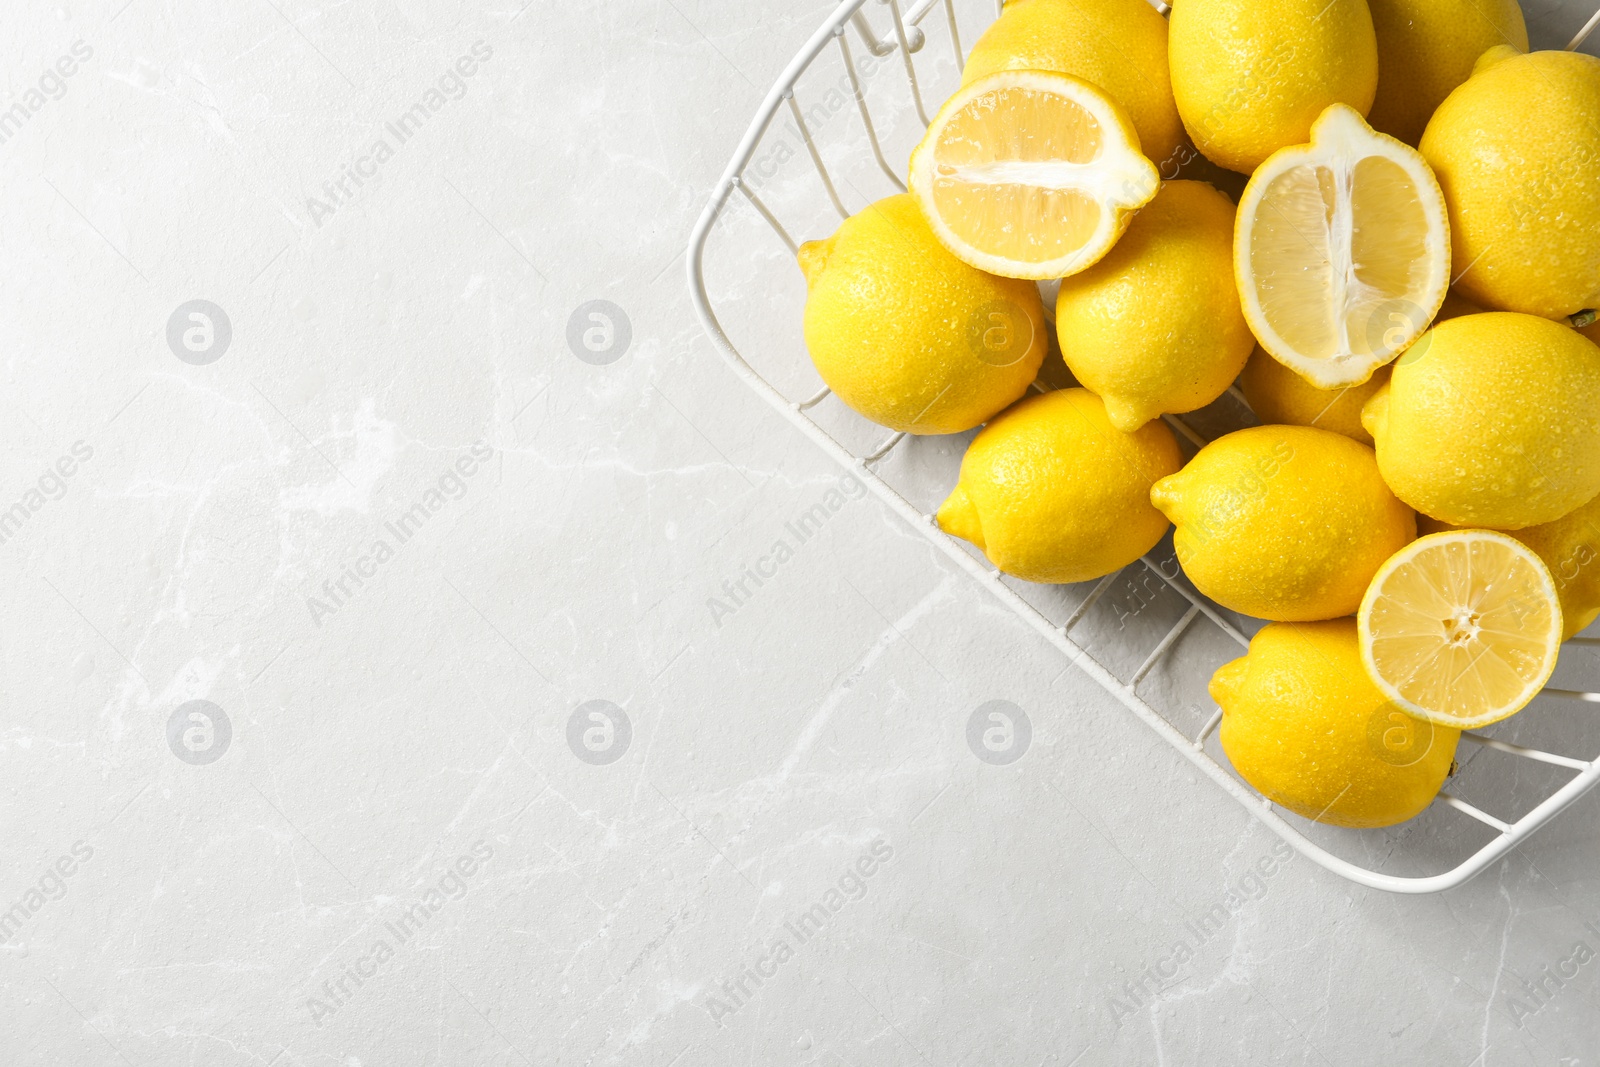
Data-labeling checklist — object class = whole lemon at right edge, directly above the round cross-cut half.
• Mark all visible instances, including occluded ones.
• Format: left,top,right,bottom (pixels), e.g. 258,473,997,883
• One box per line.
1362,312,1600,530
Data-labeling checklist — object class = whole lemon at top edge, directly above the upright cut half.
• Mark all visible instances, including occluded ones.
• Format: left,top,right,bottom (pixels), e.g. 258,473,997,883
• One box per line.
1168,0,1378,174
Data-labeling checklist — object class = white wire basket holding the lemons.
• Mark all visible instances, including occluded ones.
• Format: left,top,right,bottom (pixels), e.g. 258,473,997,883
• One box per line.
688,0,1600,893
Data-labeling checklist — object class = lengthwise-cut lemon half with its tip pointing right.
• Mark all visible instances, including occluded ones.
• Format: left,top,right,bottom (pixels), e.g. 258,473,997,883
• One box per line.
910,70,1160,280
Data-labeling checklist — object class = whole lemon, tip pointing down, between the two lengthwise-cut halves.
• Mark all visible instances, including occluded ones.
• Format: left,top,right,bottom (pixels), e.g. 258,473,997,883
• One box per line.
1056,181,1254,432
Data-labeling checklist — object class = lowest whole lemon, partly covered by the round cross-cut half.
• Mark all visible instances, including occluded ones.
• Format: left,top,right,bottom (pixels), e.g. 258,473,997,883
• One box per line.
1210,619,1461,827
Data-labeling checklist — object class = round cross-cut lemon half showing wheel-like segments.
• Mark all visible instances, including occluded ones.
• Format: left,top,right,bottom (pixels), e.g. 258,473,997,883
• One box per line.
1355,530,1562,729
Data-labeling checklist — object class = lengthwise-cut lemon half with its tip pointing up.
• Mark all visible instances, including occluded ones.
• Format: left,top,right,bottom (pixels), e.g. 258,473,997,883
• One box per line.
1234,104,1450,389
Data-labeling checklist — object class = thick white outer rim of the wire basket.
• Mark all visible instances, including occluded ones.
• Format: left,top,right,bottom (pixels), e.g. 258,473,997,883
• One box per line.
685,0,1600,894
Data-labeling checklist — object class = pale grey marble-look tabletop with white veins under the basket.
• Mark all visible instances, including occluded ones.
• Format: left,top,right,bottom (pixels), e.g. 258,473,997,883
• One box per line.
0,0,1600,1067
